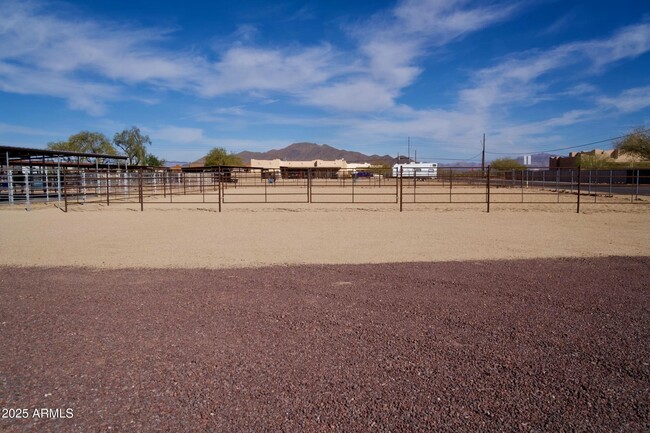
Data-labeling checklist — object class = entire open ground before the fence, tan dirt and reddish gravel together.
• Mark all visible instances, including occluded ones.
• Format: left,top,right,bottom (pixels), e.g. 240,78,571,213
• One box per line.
0,203,650,432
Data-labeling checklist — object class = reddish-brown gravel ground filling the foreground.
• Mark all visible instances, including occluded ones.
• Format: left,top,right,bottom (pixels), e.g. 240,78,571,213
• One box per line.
0,257,650,432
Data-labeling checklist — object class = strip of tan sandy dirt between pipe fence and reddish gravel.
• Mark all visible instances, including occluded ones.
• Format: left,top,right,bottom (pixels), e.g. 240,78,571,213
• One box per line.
0,203,650,268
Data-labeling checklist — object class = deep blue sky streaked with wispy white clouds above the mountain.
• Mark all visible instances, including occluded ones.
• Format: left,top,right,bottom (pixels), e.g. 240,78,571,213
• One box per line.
0,0,650,161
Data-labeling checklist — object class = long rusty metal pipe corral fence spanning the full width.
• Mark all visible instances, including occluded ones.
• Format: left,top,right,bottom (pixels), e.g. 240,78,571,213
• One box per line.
0,166,650,212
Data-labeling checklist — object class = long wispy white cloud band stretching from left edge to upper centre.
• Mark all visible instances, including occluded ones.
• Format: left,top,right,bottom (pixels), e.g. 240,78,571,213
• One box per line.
0,0,515,114
